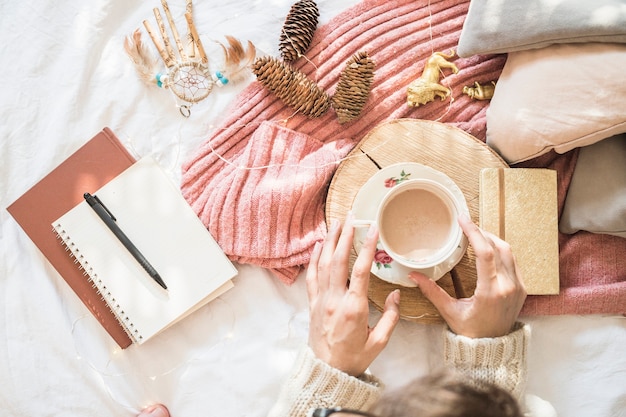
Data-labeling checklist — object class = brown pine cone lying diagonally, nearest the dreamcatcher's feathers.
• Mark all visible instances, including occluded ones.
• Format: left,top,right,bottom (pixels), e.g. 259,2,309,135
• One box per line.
252,57,330,118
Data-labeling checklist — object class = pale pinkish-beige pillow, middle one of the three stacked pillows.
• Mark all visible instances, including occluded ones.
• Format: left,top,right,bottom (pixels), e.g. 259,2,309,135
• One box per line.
487,43,626,164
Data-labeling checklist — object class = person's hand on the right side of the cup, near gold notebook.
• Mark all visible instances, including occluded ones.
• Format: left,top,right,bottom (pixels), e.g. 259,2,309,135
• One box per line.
409,215,526,338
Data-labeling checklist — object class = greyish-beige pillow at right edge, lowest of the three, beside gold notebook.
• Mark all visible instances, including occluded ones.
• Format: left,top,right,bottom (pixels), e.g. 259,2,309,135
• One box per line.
559,134,626,238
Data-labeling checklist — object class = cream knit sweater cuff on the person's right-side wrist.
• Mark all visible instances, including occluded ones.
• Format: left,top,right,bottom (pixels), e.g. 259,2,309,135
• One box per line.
444,322,530,399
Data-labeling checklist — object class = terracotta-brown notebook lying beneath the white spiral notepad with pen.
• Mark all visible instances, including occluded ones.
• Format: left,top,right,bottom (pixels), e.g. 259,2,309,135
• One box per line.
7,128,135,348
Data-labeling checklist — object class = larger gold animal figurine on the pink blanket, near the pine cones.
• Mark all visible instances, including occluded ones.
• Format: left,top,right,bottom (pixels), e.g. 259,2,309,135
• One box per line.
407,50,459,107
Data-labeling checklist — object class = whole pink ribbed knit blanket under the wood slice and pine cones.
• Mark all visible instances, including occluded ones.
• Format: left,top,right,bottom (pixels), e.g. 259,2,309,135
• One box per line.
181,0,626,315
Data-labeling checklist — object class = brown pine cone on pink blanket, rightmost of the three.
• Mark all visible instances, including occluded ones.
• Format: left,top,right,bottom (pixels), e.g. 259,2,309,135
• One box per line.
332,52,374,123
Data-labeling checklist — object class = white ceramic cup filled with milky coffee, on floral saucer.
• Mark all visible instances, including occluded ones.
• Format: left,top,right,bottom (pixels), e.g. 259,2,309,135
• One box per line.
355,179,467,270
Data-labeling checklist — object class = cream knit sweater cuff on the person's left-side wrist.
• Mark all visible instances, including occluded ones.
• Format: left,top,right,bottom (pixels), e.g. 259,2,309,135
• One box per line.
269,346,382,417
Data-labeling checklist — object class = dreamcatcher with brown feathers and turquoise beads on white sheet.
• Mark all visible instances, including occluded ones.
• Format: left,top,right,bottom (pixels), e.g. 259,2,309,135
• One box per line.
124,0,256,117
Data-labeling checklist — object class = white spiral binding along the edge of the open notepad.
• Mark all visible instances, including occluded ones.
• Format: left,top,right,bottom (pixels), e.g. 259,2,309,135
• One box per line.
52,223,143,343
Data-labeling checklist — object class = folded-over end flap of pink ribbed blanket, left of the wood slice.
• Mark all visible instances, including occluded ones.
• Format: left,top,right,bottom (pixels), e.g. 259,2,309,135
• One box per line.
185,122,351,282
